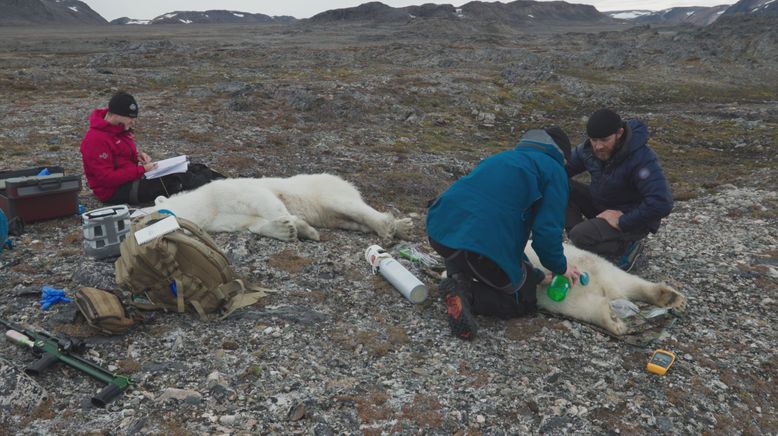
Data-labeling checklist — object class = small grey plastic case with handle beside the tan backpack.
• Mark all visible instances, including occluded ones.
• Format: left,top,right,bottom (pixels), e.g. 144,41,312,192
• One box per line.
81,204,130,259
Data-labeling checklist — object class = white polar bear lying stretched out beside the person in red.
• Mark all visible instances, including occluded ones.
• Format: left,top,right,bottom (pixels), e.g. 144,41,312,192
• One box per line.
144,174,413,241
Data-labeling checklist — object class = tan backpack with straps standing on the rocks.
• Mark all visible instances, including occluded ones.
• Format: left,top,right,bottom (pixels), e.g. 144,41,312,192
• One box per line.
115,212,272,320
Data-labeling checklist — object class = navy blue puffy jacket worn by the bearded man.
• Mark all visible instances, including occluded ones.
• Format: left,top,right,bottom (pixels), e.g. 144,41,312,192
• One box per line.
567,120,673,233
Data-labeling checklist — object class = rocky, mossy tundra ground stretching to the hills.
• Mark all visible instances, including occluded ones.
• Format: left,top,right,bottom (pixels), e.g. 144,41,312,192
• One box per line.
0,19,778,434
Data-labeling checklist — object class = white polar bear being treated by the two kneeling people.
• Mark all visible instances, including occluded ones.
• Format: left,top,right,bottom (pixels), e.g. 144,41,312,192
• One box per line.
525,243,686,335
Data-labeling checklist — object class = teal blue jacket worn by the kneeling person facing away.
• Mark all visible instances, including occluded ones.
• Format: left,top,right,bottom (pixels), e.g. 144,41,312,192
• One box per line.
427,130,570,287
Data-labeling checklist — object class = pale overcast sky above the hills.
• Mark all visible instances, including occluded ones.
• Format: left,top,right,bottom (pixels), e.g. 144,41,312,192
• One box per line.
81,0,736,21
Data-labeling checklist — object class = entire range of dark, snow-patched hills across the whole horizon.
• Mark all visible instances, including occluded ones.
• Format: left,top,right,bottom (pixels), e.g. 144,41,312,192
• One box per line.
0,0,778,27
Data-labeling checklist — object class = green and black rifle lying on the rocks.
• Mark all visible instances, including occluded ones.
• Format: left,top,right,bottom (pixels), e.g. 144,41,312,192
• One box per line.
0,319,132,407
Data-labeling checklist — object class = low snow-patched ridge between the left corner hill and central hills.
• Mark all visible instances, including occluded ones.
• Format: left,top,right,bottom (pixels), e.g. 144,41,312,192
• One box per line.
111,10,297,24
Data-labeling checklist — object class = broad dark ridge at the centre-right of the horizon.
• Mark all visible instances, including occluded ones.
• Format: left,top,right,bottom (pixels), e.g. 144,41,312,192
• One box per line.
308,0,615,25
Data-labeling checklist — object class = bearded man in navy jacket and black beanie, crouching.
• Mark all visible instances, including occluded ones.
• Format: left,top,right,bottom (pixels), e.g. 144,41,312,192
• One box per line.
565,109,673,271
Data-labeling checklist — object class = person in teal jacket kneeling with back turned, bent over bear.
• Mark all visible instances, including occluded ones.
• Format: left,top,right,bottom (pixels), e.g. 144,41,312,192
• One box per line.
427,126,579,340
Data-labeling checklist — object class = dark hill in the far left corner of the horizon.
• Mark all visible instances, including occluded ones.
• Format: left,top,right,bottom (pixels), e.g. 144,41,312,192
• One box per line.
0,0,108,26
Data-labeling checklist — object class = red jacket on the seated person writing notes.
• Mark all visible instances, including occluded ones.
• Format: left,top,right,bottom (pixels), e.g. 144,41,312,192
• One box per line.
81,108,146,201
